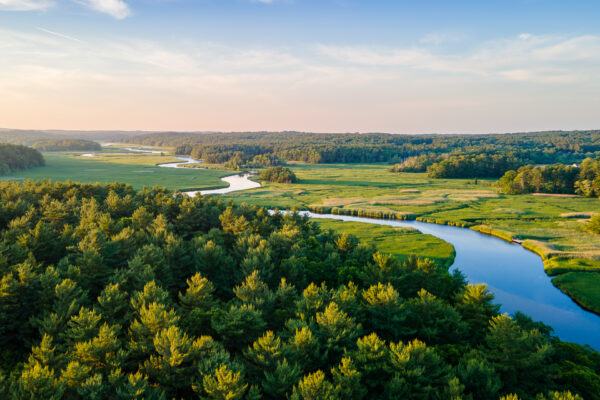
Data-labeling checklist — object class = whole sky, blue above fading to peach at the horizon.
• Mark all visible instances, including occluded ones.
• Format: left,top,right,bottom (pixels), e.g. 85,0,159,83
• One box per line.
0,0,600,133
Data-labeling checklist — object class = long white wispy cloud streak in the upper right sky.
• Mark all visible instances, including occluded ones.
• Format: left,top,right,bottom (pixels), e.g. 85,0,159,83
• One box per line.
316,33,600,83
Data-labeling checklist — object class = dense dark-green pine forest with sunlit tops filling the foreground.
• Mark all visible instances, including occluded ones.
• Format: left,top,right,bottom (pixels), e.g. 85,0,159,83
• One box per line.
0,181,600,400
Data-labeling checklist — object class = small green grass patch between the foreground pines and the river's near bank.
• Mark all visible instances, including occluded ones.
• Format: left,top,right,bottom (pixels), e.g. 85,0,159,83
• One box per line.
314,219,456,267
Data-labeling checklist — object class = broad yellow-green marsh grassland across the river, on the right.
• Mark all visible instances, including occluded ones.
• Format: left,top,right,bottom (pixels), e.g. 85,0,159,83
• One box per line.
223,164,600,312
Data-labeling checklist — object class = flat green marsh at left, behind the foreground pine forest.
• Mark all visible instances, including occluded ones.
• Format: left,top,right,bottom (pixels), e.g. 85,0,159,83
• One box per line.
2,152,232,190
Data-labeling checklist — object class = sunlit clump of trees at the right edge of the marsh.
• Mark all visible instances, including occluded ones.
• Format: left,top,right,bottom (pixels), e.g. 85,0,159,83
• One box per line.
498,158,600,197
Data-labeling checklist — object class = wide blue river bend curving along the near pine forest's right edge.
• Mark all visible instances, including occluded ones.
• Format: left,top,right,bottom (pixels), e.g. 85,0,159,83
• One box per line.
294,211,600,350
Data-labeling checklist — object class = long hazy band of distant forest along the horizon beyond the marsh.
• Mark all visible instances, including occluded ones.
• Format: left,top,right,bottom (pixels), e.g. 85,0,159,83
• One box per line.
124,131,600,171
